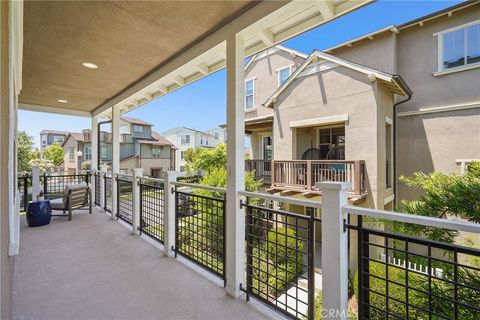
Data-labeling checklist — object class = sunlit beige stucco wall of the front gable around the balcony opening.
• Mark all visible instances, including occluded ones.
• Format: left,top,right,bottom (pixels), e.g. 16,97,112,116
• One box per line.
273,67,392,209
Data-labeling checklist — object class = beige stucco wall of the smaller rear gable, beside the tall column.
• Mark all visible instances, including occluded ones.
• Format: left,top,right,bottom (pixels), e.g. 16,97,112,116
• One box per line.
245,50,303,119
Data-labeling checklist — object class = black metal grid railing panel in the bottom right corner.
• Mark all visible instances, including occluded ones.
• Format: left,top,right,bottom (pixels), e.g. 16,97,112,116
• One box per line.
348,217,480,319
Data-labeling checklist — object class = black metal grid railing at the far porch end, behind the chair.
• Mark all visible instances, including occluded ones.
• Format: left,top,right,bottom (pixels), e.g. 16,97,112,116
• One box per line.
42,173,90,199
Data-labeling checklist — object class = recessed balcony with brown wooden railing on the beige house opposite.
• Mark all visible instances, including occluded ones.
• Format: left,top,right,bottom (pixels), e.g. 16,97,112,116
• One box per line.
246,125,366,201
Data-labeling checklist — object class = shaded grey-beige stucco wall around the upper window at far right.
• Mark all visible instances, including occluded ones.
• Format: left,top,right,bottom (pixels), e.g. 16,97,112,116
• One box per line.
333,4,480,199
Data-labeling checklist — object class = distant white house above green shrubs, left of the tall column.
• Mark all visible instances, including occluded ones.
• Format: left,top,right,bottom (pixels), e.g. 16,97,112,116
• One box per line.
163,127,226,172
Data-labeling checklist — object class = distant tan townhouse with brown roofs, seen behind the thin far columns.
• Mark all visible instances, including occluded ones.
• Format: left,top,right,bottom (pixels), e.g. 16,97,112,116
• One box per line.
60,116,175,178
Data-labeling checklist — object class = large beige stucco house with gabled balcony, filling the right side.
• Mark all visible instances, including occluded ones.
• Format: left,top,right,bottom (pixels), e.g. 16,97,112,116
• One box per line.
245,2,480,209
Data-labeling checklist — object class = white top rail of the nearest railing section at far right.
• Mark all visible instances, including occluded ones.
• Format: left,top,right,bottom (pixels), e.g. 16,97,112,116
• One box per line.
342,205,480,234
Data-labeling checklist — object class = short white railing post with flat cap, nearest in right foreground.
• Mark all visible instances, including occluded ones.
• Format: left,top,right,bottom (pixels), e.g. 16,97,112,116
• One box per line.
319,182,351,319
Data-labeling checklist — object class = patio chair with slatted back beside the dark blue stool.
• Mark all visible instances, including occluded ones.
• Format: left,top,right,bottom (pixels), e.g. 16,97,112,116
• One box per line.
50,184,92,221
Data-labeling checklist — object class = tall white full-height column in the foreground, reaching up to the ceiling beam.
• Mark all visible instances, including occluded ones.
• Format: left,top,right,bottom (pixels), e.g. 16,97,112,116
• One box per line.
225,35,245,297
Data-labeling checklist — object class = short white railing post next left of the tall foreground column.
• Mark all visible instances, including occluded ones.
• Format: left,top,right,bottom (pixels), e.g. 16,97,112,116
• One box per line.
163,171,178,257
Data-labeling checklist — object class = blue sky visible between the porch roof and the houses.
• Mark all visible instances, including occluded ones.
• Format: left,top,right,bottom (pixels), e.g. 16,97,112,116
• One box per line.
18,0,461,146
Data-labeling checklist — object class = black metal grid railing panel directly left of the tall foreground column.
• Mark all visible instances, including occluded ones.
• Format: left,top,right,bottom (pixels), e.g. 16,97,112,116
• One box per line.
174,190,225,279
